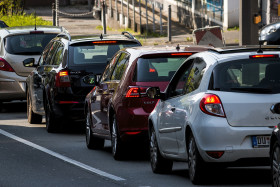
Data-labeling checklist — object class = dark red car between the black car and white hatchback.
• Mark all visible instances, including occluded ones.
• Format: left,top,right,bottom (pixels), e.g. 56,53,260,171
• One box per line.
85,46,208,160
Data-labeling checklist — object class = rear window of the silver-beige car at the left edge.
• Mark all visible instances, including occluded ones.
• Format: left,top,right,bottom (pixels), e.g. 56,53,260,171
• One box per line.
4,33,57,55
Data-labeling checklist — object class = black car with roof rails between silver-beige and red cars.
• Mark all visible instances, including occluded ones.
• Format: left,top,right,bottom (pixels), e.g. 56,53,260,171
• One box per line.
23,32,141,132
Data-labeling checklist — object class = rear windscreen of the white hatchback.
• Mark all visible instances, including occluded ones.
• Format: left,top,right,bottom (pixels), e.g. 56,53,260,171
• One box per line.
209,58,280,93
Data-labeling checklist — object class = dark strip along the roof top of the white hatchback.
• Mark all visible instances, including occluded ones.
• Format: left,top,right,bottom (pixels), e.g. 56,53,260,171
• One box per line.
208,45,280,54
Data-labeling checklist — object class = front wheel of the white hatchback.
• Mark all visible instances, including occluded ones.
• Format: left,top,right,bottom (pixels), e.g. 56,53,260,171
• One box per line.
150,128,173,173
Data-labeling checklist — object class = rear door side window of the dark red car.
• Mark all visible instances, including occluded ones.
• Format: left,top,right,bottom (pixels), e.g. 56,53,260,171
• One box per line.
111,53,129,80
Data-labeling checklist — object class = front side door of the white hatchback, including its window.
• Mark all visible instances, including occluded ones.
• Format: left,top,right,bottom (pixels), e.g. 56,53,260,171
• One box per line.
158,60,193,154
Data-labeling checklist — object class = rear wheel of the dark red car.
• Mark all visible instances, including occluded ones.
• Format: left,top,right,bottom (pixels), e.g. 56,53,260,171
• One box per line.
111,115,124,160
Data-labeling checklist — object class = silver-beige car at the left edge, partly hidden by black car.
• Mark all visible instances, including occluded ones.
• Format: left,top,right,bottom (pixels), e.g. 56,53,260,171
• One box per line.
0,26,67,102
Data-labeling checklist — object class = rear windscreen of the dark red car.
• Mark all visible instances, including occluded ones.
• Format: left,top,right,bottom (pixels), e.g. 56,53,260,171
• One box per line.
135,54,188,82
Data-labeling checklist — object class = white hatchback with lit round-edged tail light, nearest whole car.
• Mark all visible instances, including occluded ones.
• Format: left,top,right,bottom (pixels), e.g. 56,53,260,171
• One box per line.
147,46,280,184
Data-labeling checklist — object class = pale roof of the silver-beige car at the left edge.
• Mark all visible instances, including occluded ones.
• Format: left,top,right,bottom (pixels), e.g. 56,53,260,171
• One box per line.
0,25,67,35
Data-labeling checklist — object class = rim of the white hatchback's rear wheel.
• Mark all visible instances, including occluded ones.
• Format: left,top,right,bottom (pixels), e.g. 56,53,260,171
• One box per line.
188,138,197,179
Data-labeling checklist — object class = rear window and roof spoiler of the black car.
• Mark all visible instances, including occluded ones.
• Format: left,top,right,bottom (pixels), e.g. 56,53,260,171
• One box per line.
69,41,140,66
